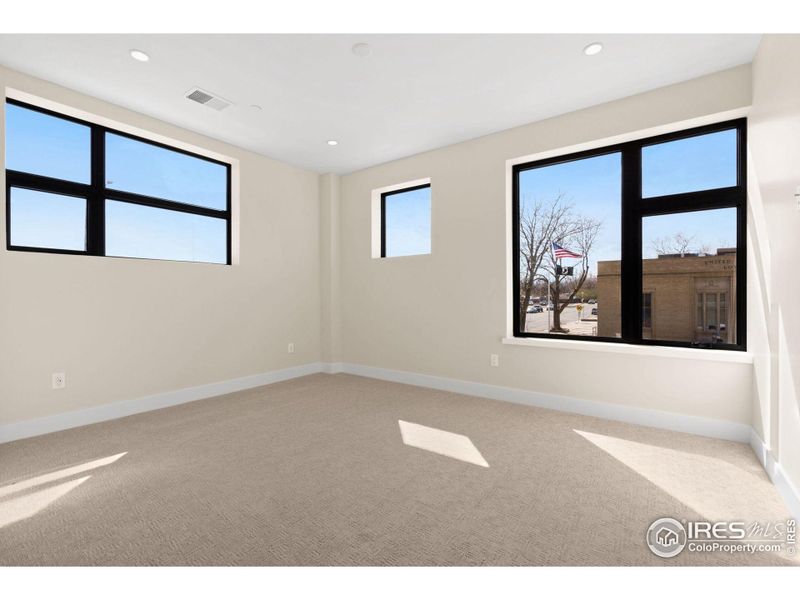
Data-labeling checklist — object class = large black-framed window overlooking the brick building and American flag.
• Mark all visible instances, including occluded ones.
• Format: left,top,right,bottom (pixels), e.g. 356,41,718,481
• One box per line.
513,119,747,350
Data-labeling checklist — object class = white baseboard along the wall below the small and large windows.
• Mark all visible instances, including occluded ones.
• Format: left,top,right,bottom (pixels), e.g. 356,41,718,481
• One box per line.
340,363,751,443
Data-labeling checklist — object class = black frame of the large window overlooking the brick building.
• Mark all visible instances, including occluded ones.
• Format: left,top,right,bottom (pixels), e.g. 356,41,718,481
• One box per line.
512,118,747,351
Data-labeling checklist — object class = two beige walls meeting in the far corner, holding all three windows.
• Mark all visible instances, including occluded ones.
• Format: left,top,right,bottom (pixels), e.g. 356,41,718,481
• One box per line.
0,55,780,440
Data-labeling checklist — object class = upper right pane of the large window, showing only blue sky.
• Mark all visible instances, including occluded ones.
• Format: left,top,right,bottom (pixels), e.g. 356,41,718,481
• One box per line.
642,129,737,198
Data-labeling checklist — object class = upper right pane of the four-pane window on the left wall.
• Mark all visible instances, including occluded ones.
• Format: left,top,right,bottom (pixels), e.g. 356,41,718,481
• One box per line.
106,133,228,210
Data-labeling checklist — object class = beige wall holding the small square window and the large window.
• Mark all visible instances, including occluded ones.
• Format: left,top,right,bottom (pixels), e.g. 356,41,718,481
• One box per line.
338,66,752,424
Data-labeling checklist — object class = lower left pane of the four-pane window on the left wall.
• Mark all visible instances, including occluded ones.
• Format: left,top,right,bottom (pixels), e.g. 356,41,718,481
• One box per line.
10,188,86,250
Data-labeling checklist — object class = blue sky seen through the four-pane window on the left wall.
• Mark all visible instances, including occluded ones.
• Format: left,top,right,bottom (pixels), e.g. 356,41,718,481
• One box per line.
6,104,227,263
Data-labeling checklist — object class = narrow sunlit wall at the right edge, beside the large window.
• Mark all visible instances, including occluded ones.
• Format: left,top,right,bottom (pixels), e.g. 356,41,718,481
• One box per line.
749,35,800,494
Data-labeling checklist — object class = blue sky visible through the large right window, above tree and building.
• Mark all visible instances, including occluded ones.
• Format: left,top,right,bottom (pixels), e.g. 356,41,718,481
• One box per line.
519,130,736,274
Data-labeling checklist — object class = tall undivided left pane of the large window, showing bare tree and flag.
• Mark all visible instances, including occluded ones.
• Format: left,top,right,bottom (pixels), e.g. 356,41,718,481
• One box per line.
517,153,622,337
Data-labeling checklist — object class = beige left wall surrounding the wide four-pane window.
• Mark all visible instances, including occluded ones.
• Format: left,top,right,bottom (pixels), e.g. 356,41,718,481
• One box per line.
0,68,321,424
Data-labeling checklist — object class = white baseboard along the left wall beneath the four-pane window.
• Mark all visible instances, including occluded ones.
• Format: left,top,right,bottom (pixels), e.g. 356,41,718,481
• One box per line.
0,363,325,444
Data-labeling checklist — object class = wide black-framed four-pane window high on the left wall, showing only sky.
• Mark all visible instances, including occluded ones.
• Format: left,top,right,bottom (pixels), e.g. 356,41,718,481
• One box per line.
6,100,231,264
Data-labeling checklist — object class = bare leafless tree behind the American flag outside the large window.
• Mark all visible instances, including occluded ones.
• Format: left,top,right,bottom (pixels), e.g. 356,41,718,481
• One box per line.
519,194,601,332
